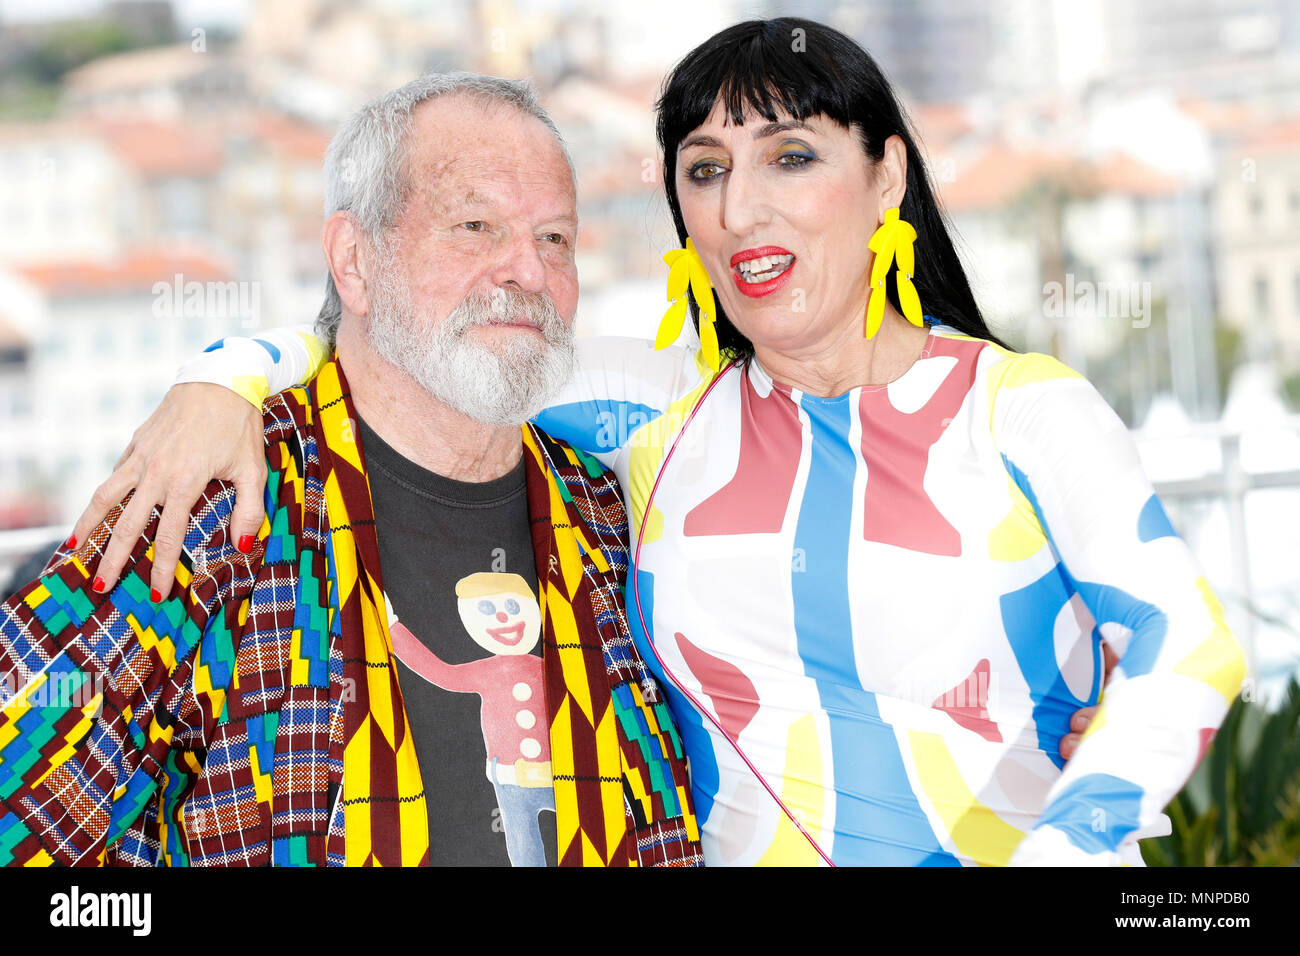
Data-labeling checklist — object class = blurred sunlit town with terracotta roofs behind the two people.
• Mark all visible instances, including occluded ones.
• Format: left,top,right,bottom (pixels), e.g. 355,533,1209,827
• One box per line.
0,0,1300,697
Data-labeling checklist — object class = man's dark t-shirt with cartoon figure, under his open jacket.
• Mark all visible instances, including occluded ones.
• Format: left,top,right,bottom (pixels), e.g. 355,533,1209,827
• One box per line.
360,421,556,866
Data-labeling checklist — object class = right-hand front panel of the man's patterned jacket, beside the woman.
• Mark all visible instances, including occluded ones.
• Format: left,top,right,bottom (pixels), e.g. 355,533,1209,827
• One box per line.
524,427,702,866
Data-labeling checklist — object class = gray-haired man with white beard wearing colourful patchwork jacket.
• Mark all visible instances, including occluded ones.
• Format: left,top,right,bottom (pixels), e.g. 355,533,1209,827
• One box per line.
0,74,701,866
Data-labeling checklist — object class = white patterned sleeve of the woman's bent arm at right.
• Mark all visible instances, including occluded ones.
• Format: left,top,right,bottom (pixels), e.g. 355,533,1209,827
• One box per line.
991,355,1245,865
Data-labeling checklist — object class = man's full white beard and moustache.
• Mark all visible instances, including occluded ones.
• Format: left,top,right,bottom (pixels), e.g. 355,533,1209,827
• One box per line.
367,260,573,425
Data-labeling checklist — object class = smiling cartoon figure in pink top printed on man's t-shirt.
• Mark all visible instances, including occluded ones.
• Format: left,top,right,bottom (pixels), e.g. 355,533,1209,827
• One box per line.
389,571,555,866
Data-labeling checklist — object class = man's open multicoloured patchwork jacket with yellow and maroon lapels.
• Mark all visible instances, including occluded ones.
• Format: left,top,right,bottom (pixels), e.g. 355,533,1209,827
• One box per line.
0,362,701,866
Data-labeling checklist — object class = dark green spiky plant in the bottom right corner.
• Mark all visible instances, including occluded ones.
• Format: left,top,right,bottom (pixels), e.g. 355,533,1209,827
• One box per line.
1141,678,1300,866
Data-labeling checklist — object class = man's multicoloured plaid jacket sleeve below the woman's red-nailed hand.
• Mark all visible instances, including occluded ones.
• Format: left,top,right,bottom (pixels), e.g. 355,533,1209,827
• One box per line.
0,481,261,865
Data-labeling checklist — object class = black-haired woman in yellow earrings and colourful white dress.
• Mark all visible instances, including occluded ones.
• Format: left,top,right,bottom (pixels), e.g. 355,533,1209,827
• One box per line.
68,18,1243,865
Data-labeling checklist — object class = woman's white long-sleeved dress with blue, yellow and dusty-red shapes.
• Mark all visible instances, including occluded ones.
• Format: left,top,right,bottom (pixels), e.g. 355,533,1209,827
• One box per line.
182,320,1244,865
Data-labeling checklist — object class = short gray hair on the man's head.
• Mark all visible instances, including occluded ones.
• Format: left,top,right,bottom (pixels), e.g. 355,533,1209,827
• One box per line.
316,72,576,349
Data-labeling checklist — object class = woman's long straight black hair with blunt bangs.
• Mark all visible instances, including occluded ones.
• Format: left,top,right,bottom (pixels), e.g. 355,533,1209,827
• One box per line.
657,17,1004,359
